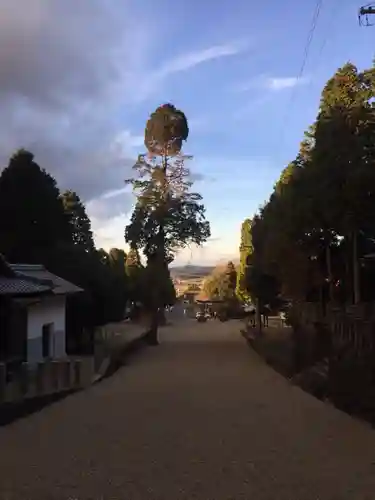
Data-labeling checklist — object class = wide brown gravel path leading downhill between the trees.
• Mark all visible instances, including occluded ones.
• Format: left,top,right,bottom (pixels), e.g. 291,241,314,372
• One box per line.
0,320,375,500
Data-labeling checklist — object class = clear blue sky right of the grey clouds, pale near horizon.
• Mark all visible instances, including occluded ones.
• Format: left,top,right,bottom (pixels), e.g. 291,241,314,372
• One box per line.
92,0,375,263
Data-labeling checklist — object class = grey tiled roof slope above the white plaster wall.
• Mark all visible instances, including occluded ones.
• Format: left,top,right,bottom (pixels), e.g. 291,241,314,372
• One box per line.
9,264,83,295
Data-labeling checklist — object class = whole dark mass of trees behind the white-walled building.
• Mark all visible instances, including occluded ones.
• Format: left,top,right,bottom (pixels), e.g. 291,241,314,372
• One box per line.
0,149,142,349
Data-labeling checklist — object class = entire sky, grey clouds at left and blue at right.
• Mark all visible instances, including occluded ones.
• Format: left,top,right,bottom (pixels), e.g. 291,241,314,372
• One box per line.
0,0,375,265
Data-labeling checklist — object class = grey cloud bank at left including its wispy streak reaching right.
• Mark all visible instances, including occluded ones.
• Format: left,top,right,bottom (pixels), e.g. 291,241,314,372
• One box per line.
0,0,251,254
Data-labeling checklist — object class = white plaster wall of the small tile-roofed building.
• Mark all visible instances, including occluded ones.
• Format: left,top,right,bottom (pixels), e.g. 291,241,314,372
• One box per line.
27,296,66,361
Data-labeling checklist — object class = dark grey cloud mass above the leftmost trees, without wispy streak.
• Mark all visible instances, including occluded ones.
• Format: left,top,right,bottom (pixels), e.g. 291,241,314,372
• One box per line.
0,0,148,205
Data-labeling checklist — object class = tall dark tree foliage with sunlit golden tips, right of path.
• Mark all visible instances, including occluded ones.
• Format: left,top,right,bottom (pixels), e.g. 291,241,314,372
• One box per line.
247,63,375,302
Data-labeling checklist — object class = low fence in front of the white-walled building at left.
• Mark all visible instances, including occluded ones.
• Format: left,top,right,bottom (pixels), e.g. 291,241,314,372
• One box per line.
0,357,94,403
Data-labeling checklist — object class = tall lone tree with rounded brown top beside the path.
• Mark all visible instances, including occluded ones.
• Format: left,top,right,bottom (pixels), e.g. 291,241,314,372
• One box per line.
125,104,210,345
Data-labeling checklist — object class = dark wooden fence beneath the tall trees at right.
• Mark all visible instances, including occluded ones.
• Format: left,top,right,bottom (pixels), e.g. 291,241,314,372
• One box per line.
292,303,375,412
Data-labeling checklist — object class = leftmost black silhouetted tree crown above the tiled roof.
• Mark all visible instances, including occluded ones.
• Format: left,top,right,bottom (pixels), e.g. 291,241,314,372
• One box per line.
0,149,72,263
